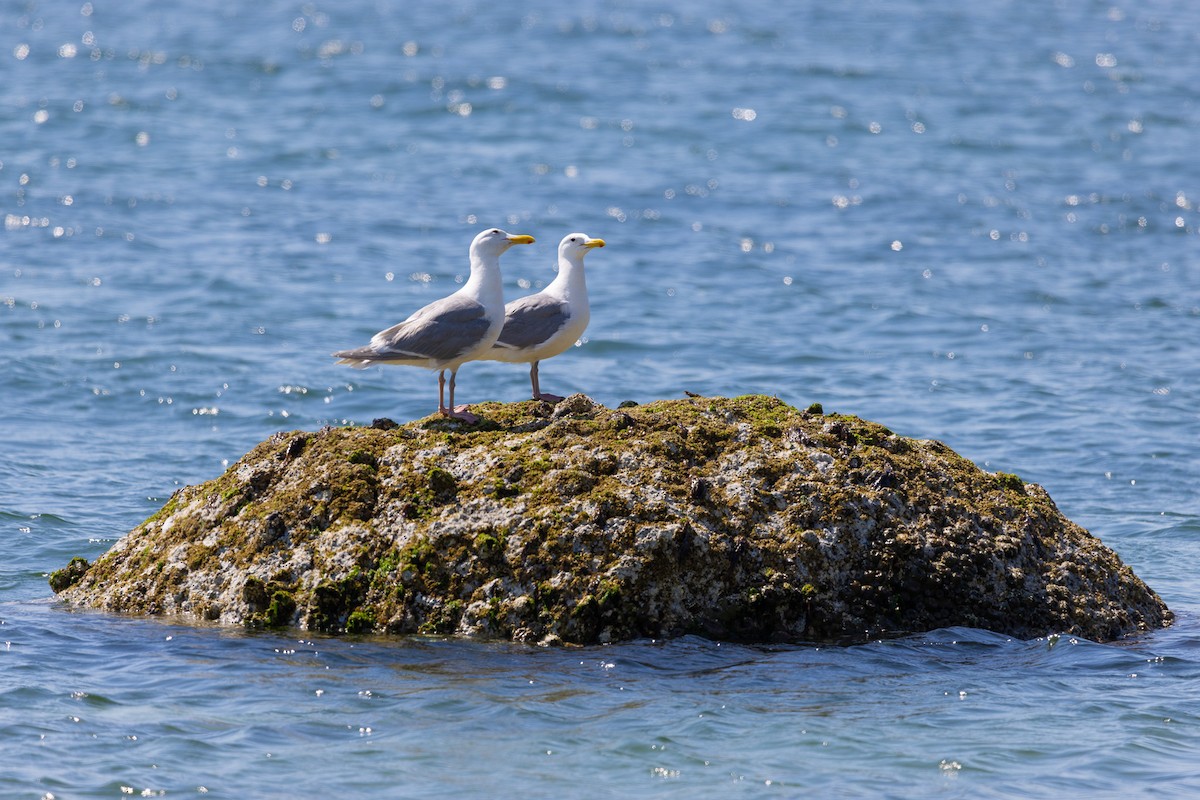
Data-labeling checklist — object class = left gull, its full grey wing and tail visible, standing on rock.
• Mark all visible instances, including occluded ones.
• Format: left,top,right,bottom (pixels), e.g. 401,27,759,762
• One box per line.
334,228,534,423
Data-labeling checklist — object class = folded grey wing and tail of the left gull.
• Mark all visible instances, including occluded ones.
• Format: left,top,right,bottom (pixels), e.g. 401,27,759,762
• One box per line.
334,295,491,361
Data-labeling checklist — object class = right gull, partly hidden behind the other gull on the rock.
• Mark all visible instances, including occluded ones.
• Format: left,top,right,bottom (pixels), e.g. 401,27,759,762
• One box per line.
480,233,605,403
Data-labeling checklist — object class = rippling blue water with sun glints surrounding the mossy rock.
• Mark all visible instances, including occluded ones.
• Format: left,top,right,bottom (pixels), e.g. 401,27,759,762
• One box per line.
0,0,1200,798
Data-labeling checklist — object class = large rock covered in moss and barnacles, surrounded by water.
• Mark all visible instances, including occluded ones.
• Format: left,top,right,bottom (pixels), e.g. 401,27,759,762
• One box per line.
52,395,1172,643
